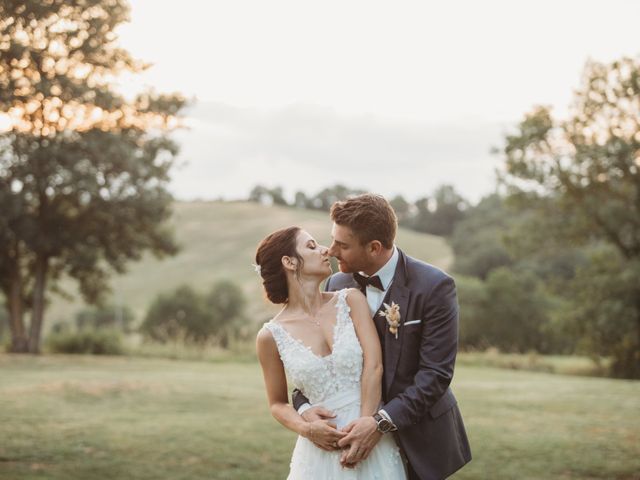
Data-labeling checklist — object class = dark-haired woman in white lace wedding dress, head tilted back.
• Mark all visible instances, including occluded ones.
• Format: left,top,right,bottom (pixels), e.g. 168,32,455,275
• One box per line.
256,227,406,480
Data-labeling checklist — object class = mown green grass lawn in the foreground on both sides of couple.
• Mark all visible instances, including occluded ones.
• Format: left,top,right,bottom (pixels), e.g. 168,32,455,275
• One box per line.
0,354,640,480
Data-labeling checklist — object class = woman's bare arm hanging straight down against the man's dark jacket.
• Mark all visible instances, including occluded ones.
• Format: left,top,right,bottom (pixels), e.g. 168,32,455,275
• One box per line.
347,289,382,417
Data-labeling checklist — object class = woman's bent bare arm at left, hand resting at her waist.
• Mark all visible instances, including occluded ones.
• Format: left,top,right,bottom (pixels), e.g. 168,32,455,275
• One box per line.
256,328,345,450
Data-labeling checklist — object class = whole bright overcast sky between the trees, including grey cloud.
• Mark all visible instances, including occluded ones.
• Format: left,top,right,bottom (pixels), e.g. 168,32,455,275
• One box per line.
118,0,640,201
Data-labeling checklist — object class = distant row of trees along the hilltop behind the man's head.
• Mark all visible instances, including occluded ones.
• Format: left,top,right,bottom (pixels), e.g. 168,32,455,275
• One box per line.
248,184,469,236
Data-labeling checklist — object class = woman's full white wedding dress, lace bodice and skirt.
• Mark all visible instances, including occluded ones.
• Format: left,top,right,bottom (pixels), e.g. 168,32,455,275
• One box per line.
264,289,406,480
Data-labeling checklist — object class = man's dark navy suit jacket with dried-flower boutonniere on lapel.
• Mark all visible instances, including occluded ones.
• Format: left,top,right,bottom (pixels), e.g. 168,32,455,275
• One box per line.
293,250,471,480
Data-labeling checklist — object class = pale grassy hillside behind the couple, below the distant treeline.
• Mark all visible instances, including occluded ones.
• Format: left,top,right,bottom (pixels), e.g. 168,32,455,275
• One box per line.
45,202,453,329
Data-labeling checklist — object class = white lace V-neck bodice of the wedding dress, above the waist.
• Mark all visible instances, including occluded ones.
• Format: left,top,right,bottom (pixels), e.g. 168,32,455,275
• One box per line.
264,289,363,404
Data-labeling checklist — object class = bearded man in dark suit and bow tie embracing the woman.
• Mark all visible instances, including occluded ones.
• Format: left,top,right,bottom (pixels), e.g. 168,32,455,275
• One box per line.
293,194,471,480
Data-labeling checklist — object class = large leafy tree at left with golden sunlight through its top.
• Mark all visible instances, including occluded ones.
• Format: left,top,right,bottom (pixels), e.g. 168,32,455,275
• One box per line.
0,0,184,352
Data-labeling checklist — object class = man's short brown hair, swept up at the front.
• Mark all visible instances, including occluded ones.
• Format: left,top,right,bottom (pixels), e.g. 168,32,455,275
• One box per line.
331,193,398,249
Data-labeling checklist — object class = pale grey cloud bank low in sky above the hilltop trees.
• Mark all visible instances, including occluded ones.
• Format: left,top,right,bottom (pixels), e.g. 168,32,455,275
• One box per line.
172,102,504,200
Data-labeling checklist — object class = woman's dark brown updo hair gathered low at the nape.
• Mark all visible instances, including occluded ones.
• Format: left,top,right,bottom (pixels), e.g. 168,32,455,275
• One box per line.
256,227,302,303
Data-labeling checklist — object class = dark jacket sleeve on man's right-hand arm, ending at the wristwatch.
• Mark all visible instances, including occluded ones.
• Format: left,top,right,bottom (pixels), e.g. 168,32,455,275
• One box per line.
382,277,458,430
